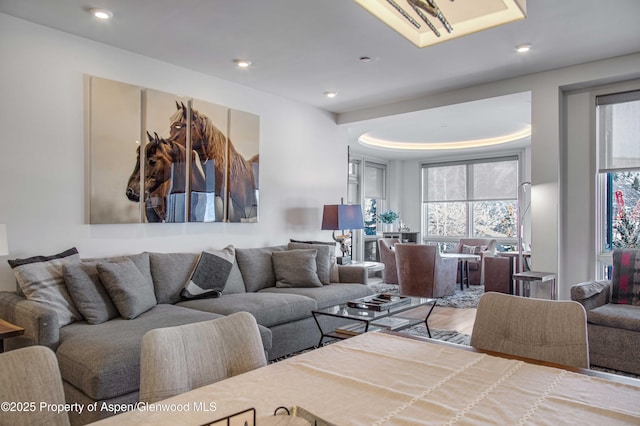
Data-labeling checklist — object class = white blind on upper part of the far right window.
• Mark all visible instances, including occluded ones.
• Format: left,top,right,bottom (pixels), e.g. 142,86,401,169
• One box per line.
596,91,640,173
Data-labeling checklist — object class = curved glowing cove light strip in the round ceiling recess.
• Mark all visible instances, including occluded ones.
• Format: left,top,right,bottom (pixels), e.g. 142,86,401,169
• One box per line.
358,125,531,151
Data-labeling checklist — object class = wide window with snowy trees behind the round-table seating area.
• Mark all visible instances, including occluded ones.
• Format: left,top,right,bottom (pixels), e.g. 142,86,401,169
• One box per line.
422,156,518,248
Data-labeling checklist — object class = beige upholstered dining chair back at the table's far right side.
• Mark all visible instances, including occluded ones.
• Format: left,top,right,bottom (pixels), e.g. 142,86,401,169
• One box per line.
471,292,589,368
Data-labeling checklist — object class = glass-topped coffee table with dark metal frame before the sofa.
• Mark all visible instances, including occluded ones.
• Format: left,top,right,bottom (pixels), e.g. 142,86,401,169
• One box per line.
311,296,438,346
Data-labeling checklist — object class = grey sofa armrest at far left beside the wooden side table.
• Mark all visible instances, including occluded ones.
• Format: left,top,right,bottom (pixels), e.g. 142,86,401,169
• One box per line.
0,291,60,349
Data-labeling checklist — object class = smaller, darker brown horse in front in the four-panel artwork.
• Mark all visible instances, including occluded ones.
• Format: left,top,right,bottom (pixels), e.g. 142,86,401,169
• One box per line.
126,132,206,222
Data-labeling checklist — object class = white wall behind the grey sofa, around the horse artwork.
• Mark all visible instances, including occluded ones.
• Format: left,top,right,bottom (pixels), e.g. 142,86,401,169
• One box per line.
0,14,347,290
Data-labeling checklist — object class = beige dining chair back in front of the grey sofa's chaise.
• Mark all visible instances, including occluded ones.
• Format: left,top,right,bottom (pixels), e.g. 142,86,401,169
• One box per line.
140,312,267,403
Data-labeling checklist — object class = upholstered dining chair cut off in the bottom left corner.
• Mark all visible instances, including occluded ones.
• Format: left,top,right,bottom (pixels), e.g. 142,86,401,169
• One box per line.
0,346,69,426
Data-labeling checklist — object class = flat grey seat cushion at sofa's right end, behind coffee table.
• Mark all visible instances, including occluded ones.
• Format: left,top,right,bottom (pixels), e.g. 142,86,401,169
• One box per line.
259,283,375,309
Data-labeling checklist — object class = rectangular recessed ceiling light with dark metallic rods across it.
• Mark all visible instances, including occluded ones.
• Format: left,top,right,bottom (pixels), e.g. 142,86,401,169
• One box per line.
353,0,526,47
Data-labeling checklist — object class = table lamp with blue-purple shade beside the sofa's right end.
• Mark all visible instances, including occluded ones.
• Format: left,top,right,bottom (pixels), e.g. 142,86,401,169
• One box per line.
322,204,364,265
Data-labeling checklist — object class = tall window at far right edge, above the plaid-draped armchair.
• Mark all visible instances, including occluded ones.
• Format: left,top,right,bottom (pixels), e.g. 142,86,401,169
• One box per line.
596,91,640,278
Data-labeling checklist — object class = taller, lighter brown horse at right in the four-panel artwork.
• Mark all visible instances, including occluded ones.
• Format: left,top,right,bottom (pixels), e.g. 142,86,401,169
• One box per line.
169,102,260,222
